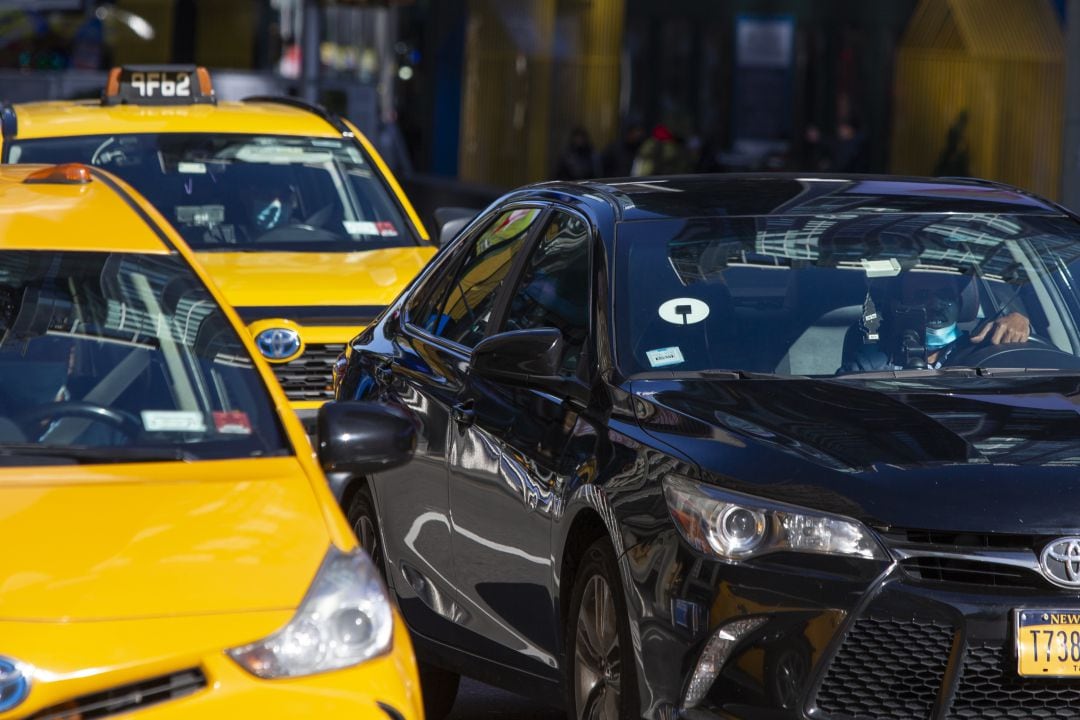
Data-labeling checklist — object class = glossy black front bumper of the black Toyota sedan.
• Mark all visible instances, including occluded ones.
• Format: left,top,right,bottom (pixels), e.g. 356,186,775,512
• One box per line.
627,528,1080,720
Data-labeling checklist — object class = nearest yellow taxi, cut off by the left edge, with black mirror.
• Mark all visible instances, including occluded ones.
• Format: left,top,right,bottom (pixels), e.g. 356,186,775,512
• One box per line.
0,165,422,720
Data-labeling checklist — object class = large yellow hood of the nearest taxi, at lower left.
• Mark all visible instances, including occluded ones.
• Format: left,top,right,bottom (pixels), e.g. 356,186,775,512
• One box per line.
0,458,330,622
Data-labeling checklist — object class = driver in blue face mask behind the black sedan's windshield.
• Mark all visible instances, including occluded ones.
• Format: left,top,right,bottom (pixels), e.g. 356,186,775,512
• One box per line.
839,272,1031,373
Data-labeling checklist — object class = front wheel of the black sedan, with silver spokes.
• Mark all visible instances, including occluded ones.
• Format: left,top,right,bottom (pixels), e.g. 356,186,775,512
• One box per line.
564,539,642,720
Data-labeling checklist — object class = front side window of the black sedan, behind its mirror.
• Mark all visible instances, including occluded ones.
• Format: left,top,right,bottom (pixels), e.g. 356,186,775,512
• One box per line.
505,213,590,375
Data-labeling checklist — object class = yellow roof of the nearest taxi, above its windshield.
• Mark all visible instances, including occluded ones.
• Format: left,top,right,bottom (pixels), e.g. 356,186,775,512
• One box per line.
0,165,172,253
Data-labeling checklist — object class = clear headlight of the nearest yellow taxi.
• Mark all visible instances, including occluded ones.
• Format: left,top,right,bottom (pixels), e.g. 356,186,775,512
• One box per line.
228,547,393,679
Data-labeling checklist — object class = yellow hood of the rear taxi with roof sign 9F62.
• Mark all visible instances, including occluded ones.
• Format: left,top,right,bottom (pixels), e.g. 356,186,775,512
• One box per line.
197,246,435,308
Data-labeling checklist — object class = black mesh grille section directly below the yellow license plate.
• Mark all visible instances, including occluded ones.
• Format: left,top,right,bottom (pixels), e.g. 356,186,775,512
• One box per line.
947,646,1080,720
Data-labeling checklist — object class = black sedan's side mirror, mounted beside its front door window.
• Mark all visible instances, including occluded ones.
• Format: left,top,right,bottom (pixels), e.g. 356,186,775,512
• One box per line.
472,327,565,390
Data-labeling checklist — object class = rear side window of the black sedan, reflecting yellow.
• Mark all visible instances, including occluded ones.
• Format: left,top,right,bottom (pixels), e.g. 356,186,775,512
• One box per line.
409,207,540,348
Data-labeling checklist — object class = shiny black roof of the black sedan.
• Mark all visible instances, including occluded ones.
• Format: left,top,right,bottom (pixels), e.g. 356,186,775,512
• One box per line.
532,173,1066,221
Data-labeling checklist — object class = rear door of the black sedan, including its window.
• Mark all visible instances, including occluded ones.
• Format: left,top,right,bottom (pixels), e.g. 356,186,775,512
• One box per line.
372,206,542,642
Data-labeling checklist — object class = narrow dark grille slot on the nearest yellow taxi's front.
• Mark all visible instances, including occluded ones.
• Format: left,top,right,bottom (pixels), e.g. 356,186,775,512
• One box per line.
27,668,206,720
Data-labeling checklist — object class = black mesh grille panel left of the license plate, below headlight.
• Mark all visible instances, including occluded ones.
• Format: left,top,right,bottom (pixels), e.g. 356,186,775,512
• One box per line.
818,619,955,720
